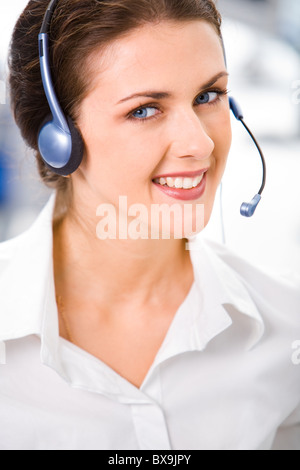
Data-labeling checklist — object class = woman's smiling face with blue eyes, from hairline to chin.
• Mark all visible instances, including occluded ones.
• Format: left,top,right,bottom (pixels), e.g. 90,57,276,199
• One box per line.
73,21,231,236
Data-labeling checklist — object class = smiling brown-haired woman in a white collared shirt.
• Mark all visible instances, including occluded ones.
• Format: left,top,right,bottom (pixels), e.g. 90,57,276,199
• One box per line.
0,0,300,450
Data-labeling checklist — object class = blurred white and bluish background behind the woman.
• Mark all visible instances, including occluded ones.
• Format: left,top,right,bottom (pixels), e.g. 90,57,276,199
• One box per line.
0,0,300,276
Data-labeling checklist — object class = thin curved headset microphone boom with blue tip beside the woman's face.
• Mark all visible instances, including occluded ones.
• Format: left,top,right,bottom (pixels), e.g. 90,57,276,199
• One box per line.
229,97,267,218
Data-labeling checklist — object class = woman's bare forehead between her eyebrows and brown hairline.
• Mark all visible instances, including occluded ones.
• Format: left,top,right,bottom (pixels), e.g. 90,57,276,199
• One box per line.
86,21,225,98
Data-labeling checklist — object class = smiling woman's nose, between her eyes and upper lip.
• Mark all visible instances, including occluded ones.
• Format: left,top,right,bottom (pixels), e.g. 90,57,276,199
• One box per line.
168,109,215,160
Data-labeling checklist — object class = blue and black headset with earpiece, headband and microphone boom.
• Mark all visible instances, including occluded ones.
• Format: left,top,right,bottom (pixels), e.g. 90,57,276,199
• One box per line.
38,0,266,217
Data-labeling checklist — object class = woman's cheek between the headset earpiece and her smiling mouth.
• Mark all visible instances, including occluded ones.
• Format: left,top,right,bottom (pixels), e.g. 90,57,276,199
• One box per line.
77,112,165,203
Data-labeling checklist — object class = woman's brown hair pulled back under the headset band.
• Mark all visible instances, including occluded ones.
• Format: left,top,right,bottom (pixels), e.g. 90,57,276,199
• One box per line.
9,0,221,217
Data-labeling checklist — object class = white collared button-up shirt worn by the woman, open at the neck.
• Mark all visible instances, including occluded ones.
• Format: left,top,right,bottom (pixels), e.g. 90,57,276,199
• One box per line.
0,195,300,450
